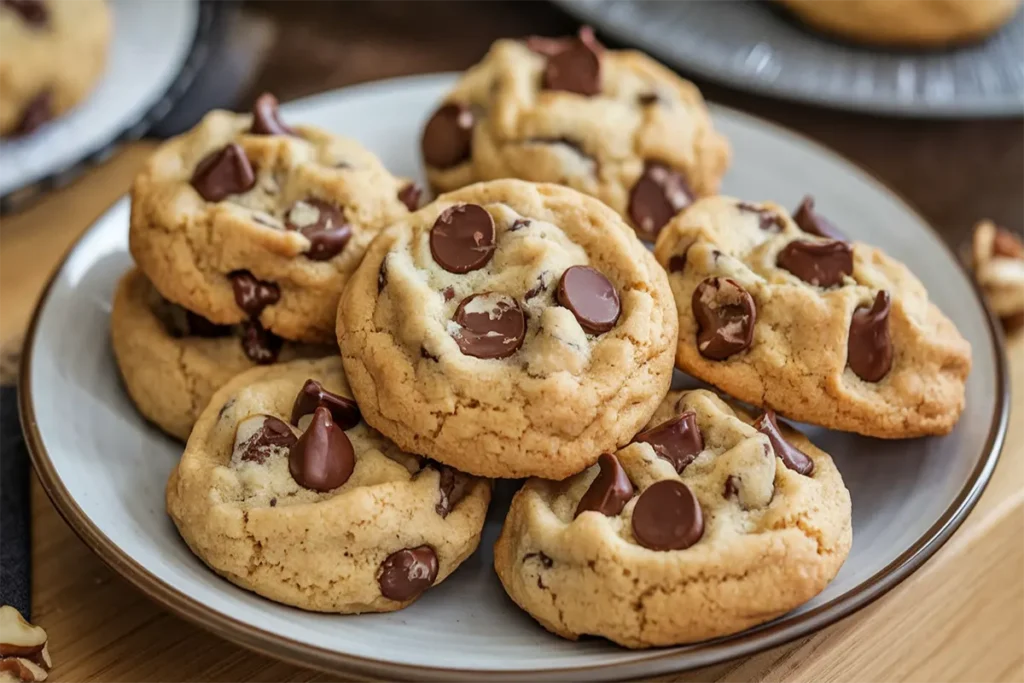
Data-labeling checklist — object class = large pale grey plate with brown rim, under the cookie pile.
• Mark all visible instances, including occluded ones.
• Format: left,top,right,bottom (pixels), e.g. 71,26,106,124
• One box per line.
20,75,1007,681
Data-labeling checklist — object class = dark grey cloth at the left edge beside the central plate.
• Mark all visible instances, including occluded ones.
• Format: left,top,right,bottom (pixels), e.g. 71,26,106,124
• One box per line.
0,387,32,618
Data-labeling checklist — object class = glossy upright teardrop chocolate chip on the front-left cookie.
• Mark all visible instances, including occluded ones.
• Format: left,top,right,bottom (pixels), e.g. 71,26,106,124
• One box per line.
288,405,355,492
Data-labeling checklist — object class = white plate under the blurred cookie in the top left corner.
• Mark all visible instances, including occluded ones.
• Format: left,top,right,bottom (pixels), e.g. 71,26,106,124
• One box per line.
0,0,200,204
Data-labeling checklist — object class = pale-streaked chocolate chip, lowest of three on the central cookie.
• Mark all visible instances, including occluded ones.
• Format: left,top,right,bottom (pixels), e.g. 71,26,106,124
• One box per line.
452,292,526,358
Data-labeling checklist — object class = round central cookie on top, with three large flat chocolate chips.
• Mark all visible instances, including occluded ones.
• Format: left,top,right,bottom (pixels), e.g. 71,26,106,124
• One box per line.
338,180,677,479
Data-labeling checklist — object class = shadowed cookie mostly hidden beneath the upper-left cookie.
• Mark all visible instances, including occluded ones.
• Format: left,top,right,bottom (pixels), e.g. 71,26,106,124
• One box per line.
111,269,333,441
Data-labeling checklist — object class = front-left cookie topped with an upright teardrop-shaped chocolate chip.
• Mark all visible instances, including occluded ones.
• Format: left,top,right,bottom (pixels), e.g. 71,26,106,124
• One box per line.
167,357,490,613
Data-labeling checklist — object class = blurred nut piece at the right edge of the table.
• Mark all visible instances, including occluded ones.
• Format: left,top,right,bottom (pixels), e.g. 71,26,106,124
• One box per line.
971,220,1024,332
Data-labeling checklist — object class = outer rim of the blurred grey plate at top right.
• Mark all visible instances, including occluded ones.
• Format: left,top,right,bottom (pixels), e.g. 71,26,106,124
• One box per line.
550,0,1024,118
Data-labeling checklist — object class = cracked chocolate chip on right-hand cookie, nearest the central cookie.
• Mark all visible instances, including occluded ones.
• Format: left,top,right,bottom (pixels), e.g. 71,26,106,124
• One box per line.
691,278,757,360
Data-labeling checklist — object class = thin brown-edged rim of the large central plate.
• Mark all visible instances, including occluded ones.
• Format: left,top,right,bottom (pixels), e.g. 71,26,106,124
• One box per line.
17,73,1010,681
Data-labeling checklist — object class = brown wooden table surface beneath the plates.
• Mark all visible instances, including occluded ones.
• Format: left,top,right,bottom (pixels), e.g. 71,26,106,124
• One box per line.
0,0,1024,683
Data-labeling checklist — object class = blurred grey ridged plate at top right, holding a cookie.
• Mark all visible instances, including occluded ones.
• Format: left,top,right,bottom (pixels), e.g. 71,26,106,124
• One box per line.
553,0,1024,118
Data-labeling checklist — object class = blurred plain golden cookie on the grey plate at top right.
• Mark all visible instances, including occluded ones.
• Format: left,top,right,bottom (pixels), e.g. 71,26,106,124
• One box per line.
774,0,1020,47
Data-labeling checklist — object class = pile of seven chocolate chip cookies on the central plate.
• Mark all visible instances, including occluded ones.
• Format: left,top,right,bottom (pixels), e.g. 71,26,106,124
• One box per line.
114,30,970,647
